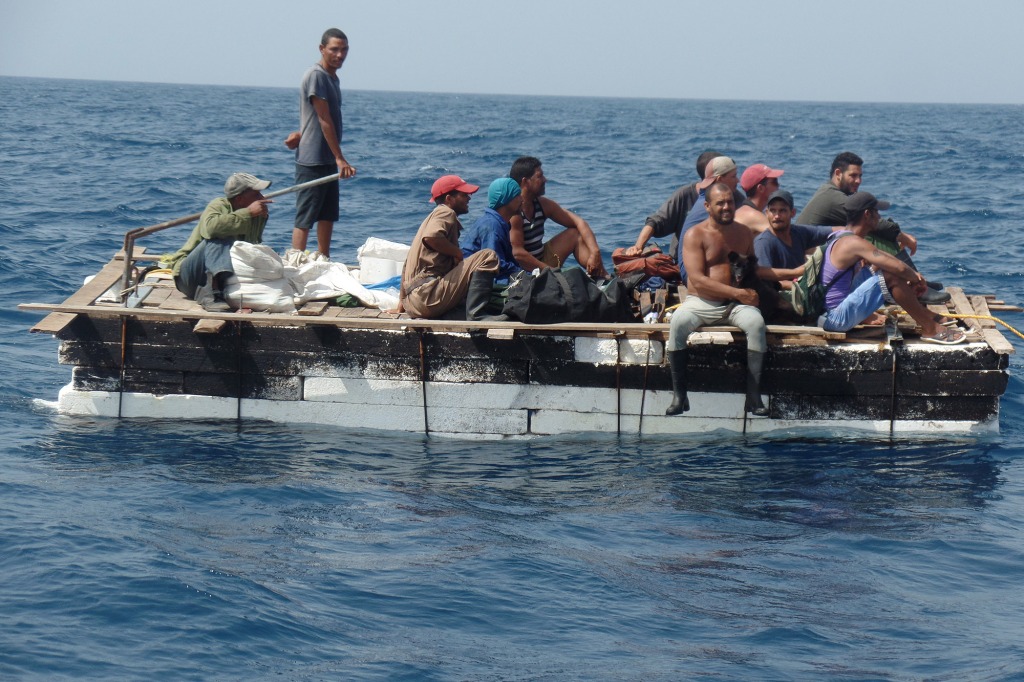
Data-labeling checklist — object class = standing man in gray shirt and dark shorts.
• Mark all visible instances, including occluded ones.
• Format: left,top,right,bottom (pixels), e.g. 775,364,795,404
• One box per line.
285,29,355,259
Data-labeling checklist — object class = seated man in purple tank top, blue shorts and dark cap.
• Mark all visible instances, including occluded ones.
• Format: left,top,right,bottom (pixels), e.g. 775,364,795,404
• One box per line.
819,191,966,345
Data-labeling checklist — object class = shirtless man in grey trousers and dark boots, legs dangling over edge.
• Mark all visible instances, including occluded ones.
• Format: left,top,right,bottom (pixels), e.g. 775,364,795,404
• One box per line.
665,182,768,417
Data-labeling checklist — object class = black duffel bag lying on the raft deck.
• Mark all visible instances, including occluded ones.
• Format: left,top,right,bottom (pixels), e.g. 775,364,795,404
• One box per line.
502,267,643,325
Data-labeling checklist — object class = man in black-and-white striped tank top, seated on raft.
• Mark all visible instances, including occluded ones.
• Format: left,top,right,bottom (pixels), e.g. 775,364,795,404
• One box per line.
509,157,608,279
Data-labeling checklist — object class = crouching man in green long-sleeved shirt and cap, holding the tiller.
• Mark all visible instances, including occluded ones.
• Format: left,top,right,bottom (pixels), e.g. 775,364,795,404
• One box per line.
165,173,272,312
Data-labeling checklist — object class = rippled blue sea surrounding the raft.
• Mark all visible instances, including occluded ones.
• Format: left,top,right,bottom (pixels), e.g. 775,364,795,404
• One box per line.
0,78,1024,681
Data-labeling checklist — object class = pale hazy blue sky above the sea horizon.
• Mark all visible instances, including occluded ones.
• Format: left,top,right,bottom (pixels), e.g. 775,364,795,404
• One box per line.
6,0,1024,103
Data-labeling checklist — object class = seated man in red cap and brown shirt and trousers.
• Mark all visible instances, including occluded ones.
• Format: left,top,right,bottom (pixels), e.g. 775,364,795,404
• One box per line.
398,175,498,319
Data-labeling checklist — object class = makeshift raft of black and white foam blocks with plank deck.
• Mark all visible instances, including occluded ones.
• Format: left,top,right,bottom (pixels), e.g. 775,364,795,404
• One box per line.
20,248,1014,438
